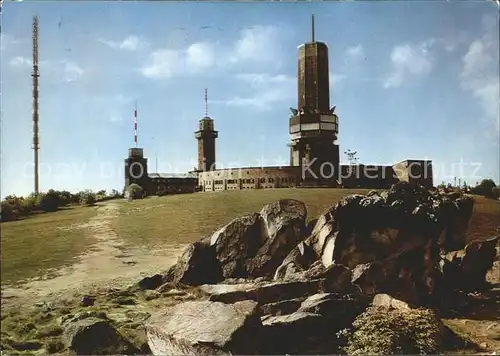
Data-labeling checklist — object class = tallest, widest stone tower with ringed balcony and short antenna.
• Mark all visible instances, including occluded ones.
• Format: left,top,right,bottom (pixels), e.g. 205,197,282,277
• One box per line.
289,15,340,185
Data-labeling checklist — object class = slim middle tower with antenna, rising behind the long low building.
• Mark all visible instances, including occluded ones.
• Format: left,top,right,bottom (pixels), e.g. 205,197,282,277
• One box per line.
194,89,219,172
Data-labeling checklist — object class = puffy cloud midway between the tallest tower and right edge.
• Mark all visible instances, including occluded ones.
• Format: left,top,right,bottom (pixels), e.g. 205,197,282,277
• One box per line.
383,39,435,88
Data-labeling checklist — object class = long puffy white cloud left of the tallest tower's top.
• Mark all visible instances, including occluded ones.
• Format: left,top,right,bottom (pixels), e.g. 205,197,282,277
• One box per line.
139,26,281,79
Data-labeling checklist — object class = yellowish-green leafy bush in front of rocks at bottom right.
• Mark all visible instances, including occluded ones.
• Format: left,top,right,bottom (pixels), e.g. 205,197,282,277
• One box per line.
345,307,445,355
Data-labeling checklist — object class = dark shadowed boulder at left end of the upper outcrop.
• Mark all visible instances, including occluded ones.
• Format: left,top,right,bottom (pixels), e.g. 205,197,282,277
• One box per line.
161,239,223,285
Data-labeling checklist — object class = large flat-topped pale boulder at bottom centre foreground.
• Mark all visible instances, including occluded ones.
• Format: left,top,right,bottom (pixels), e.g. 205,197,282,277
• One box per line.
146,301,262,355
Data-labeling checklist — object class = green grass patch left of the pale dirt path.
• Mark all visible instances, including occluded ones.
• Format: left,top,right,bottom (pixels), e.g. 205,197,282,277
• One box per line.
1,206,97,285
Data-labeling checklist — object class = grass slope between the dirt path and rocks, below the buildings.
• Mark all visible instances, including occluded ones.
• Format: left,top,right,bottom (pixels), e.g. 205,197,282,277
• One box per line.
113,188,369,246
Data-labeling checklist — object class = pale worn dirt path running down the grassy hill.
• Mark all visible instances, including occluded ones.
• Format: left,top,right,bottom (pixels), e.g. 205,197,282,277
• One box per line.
2,202,184,304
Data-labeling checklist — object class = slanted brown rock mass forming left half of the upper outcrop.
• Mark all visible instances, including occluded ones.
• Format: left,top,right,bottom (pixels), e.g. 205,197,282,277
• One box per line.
163,199,307,285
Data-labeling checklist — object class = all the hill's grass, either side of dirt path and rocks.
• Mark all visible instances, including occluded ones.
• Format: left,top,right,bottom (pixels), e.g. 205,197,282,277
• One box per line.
1,189,500,284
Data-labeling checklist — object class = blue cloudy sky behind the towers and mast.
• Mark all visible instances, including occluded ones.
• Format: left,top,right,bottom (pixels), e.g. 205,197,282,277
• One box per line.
0,1,500,197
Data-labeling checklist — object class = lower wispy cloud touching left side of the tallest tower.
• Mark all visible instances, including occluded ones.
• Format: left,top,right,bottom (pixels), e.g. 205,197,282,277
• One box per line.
222,73,297,110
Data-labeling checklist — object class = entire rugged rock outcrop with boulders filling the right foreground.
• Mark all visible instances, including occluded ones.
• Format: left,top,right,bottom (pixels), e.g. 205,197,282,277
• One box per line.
141,183,500,354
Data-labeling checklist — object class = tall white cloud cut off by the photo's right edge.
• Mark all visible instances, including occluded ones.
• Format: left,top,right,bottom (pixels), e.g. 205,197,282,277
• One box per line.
460,18,500,139
